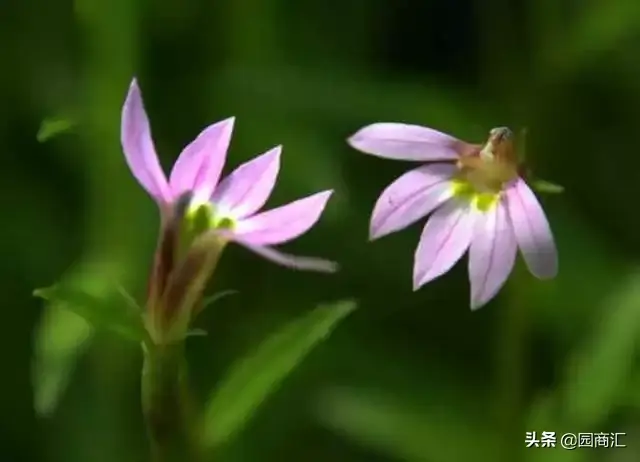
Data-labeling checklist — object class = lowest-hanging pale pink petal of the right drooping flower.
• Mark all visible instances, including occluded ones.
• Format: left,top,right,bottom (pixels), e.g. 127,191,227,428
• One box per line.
469,202,518,310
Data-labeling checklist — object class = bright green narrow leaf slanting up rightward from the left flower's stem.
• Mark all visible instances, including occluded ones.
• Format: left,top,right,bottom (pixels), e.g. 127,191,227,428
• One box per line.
203,301,356,447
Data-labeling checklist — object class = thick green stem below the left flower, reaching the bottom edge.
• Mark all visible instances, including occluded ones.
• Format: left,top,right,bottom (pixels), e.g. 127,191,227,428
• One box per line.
142,342,198,462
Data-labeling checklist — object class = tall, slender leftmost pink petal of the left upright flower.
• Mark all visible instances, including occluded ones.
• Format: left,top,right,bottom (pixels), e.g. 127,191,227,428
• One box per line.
120,79,172,203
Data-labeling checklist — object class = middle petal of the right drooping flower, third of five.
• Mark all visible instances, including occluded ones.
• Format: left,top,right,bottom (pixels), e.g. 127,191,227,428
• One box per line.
413,199,477,290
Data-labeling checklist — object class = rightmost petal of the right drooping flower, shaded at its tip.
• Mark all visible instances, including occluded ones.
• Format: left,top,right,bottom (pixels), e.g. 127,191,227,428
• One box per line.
506,178,558,279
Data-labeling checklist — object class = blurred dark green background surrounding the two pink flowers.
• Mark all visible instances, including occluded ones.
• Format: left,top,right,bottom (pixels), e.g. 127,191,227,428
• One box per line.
0,0,640,462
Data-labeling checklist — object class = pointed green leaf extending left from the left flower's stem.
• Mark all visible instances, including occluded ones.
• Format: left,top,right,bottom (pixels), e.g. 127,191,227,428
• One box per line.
33,283,148,342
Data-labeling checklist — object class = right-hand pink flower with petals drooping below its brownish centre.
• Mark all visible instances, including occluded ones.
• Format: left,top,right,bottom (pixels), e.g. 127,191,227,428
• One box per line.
349,123,558,309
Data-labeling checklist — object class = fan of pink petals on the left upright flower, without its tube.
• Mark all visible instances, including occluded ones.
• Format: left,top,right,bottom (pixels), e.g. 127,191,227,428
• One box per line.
121,79,336,272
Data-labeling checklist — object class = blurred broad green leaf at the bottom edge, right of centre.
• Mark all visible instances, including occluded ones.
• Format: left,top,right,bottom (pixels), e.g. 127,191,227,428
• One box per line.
318,388,500,462
